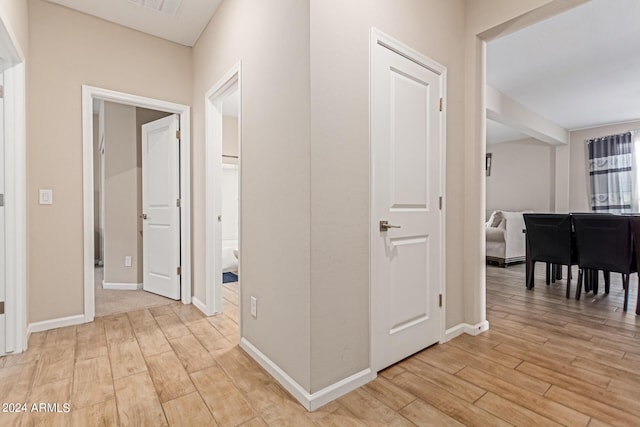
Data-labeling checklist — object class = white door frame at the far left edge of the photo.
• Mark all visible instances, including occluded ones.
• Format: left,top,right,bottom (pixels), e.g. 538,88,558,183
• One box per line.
0,11,27,353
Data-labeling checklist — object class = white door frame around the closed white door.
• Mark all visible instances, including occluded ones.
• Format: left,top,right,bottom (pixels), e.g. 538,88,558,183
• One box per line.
369,27,447,371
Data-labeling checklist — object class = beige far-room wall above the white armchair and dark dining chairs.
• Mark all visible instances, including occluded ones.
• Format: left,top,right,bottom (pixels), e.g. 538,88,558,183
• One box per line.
485,139,555,212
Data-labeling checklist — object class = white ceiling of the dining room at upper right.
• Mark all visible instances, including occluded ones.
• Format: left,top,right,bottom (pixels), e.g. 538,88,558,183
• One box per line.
487,0,640,142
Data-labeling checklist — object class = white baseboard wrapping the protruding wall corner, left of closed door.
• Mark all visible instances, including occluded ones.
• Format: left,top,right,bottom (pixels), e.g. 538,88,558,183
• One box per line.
240,338,376,411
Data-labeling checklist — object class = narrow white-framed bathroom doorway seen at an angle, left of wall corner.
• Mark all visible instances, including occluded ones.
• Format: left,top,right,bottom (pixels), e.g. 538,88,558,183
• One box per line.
202,63,242,324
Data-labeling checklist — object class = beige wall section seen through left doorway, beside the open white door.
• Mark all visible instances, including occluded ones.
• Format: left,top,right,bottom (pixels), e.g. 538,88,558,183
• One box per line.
104,102,142,284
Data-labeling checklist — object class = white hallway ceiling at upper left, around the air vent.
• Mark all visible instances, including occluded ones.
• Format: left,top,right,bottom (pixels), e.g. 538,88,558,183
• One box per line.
48,0,222,46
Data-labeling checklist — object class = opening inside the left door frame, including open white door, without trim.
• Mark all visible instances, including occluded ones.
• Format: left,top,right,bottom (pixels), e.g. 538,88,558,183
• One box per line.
93,99,180,316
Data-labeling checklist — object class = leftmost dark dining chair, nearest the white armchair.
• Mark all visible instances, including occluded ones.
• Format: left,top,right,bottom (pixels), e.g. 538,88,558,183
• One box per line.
523,213,577,298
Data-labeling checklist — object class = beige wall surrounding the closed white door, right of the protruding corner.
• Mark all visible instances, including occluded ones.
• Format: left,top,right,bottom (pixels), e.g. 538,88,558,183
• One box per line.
311,0,464,392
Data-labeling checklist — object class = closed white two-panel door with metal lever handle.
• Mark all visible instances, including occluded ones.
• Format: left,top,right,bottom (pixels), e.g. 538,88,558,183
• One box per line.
371,36,444,370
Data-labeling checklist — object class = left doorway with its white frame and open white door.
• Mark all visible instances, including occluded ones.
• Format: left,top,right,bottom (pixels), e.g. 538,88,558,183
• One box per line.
83,86,191,322
